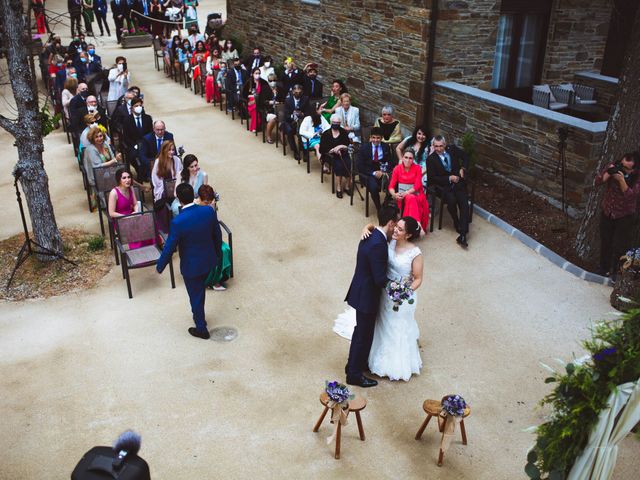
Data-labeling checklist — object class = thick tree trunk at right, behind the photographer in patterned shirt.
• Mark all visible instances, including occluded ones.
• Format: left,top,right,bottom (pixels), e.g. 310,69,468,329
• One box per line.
575,8,640,260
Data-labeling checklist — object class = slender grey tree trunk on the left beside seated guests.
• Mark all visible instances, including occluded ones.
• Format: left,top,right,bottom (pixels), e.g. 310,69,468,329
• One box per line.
0,0,63,260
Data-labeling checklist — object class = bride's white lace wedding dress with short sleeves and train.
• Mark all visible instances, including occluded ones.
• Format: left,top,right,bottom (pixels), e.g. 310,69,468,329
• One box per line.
333,240,422,381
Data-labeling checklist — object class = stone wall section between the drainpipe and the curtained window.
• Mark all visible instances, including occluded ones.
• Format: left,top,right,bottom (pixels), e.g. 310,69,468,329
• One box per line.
433,0,501,90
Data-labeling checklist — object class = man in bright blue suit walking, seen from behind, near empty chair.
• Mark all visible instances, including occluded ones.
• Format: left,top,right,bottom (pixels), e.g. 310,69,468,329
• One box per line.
156,183,222,340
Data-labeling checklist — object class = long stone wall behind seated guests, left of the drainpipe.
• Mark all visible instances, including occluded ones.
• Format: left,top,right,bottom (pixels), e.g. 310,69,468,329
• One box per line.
224,0,430,126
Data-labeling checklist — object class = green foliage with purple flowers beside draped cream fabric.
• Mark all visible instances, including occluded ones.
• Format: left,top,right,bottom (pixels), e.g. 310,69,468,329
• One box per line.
525,309,640,480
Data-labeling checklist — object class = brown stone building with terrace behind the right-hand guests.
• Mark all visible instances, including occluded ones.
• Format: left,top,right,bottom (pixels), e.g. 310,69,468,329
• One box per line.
225,0,638,210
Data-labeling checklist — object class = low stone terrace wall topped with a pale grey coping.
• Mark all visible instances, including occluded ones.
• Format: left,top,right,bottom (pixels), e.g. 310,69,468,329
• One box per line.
434,82,606,210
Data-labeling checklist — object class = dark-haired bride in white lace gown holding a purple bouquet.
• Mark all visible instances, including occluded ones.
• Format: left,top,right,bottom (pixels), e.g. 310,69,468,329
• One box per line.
333,217,424,381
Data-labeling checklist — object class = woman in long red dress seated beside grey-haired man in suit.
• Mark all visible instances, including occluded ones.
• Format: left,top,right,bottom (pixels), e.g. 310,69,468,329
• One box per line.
389,149,429,232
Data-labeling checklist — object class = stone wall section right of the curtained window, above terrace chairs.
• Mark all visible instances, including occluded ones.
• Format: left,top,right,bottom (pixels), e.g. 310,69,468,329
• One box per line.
542,0,612,84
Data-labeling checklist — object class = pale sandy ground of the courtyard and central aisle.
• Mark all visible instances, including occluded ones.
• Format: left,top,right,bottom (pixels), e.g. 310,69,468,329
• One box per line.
0,0,638,480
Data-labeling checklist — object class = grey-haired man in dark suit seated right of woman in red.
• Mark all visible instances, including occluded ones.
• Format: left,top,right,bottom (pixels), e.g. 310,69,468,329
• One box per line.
427,135,469,248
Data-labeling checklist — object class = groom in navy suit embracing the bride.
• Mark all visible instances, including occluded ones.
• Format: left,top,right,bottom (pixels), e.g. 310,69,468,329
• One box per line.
345,206,398,388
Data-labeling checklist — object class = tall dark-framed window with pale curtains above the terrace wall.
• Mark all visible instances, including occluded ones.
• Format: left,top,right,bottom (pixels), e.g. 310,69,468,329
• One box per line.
491,0,552,100
